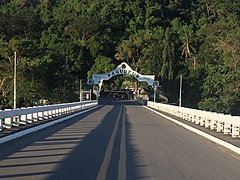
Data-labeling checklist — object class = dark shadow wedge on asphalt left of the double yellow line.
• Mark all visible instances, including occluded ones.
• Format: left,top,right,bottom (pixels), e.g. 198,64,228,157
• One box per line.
47,102,122,180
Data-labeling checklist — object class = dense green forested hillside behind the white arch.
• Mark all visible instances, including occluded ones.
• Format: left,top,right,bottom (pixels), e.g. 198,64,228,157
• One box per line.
0,0,240,114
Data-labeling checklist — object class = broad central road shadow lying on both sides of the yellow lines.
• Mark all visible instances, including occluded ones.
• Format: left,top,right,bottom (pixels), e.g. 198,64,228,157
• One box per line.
47,99,149,180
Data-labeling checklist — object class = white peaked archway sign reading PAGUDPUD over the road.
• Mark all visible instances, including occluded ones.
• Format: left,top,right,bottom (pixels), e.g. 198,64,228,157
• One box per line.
92,62,155,88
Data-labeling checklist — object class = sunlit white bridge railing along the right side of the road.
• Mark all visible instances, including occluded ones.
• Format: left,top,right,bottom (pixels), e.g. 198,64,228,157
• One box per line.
147,101,240,137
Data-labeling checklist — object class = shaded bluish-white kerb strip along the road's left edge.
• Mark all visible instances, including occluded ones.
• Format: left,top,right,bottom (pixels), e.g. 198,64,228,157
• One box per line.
0,105,102,144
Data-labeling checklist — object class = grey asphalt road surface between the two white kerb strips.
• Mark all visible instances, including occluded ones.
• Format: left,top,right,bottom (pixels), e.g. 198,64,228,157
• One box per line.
0,101,240,180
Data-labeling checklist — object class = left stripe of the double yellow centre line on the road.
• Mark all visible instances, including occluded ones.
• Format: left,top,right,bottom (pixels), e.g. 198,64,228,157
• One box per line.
96,106,123,180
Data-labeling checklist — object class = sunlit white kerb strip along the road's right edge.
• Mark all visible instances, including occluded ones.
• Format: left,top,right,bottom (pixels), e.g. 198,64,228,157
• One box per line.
144,106,240,155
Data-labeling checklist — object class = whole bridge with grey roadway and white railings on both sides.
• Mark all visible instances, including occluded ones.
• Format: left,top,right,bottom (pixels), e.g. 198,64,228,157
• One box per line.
0,100,240,180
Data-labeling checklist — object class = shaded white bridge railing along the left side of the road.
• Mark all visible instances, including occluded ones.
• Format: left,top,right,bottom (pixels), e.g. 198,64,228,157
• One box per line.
0,100,98,131
